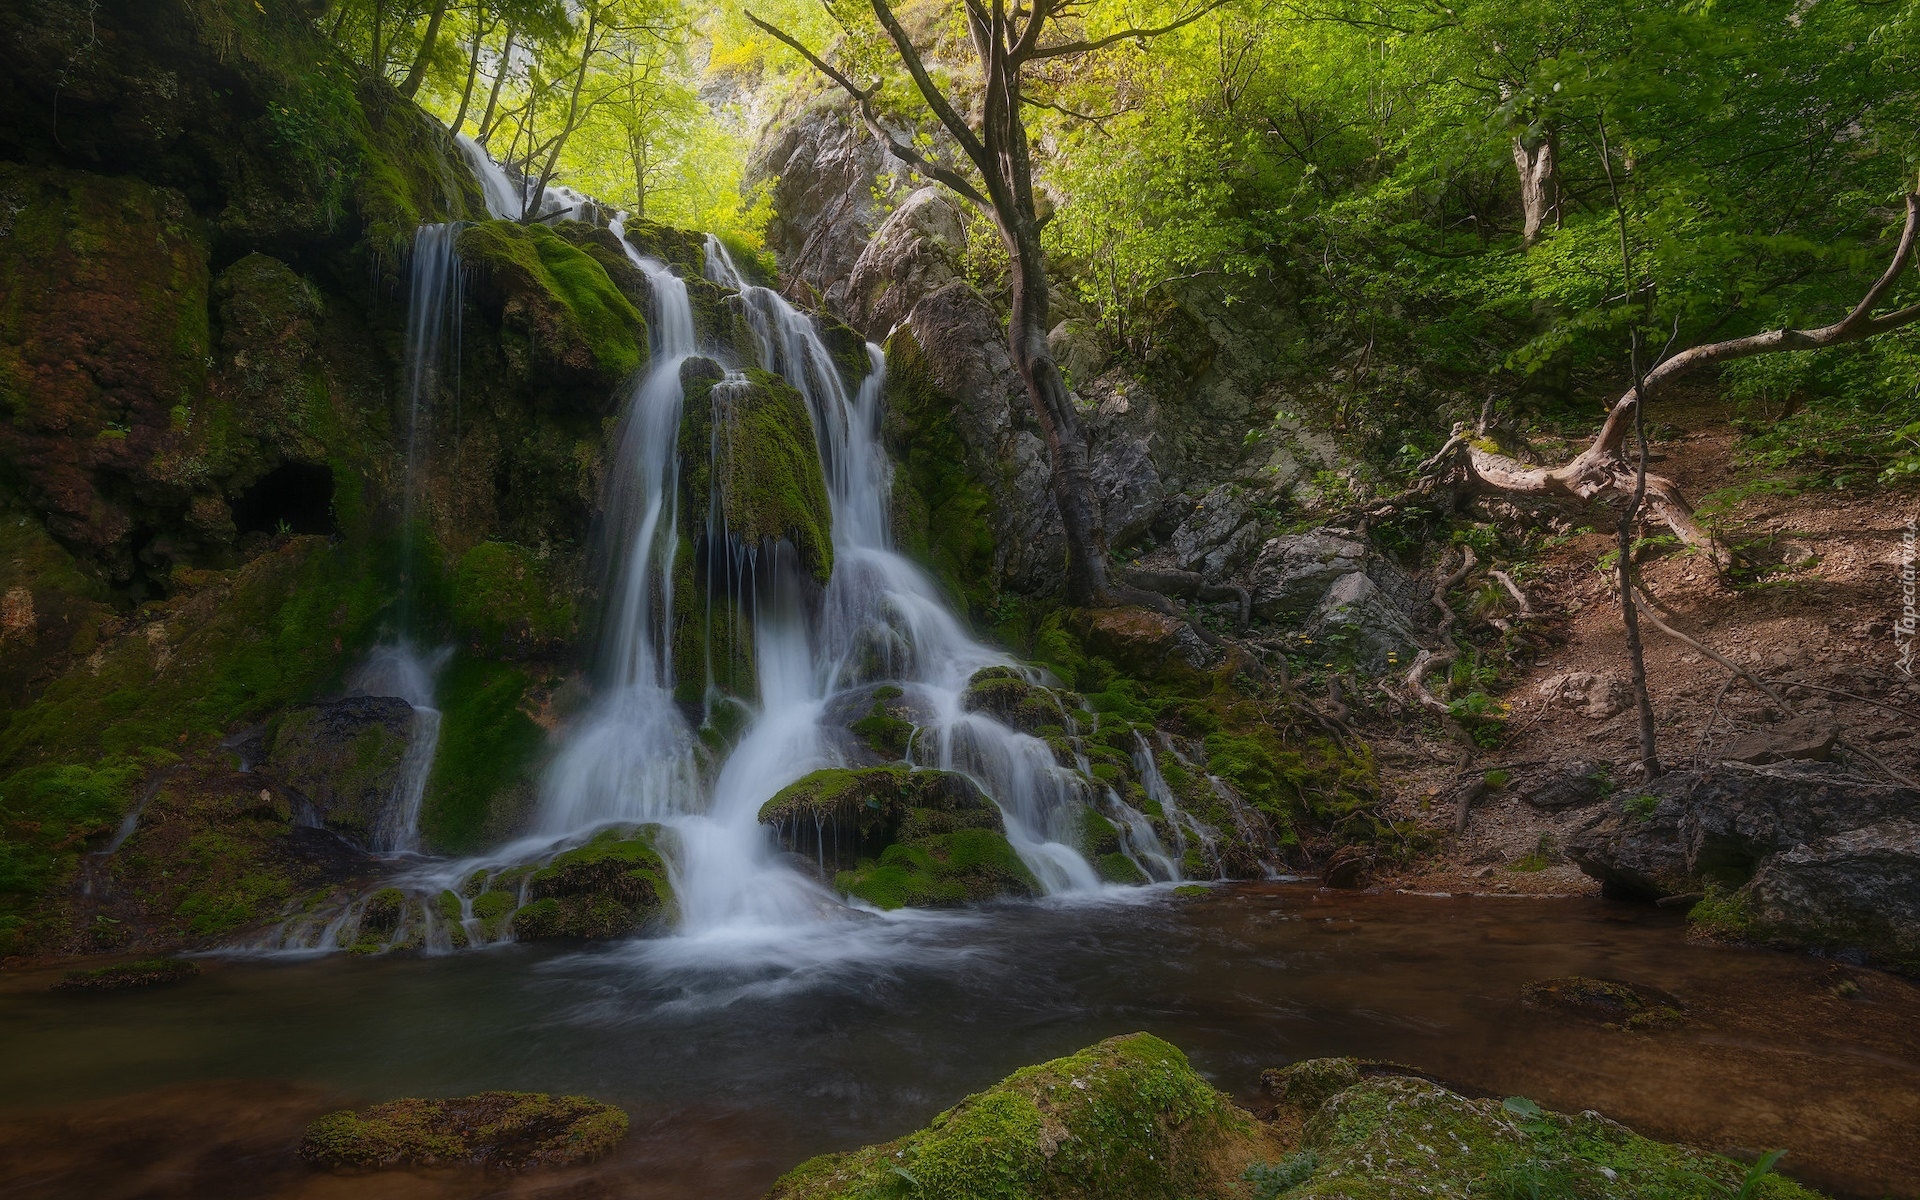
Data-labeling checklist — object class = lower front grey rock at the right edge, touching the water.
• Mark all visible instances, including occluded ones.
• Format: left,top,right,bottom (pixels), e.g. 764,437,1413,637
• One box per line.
1745,820,1920,970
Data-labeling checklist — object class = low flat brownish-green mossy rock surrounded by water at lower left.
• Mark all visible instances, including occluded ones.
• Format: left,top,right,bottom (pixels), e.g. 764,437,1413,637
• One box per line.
300,1092,626,1171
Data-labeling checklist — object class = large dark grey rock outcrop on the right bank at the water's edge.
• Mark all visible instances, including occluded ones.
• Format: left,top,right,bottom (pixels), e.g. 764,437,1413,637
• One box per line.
1567,764,1920,968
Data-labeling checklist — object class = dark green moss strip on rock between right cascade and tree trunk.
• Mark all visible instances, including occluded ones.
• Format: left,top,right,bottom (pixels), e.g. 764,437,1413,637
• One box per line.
885,326,998,606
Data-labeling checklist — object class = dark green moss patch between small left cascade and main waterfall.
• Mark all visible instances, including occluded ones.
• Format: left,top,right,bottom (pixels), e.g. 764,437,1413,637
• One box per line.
420,655,547,854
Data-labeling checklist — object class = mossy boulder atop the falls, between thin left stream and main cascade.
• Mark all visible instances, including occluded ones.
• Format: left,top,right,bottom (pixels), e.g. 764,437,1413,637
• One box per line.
459,221,647,403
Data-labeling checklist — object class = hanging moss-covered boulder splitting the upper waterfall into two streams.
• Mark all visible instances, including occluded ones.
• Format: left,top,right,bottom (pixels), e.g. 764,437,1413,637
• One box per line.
680,359,833,584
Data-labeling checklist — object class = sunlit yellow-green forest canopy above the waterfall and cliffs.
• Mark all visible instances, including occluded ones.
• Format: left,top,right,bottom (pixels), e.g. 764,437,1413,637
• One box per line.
319,0,1920,480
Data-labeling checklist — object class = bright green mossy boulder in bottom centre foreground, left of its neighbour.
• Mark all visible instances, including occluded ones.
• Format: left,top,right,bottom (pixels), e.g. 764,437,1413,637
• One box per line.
768,1033,1269,1200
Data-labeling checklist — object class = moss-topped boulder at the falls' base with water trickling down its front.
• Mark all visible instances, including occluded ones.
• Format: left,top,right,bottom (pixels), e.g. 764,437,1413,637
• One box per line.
760,766,1000,871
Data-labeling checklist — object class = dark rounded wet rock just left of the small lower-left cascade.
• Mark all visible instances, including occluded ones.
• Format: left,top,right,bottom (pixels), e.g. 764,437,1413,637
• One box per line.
267,695,413,843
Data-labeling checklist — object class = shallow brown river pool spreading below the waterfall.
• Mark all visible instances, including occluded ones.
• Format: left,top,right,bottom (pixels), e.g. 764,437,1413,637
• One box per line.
0,885,1920,1200
